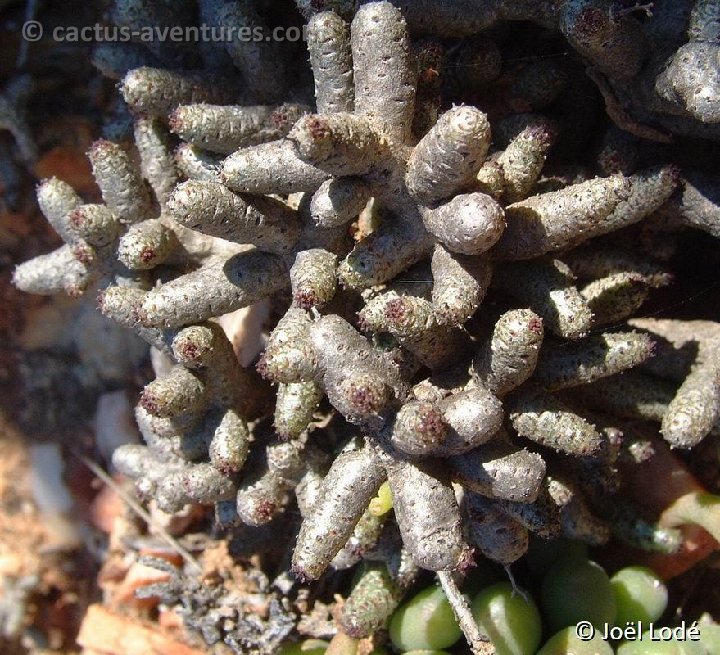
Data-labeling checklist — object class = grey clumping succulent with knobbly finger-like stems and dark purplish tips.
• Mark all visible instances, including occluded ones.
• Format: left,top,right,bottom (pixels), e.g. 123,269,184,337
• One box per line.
9,0,720,655
